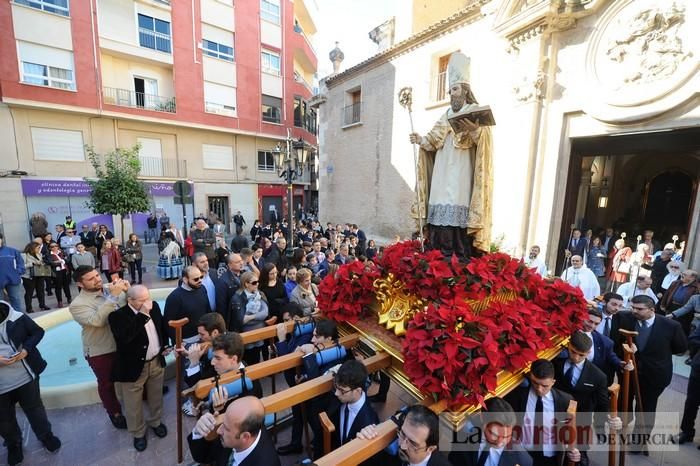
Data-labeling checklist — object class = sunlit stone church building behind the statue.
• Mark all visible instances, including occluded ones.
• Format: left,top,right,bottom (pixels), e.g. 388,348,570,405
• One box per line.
315,0,700,271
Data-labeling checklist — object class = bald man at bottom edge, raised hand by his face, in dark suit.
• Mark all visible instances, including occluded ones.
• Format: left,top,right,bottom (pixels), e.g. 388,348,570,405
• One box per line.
187,396,280,466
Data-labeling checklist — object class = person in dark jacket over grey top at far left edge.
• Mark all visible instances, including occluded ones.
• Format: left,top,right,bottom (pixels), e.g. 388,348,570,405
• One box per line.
0,301,61,466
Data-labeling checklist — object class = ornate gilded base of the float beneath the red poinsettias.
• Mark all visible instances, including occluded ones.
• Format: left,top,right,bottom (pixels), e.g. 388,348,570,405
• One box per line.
338,274,568,432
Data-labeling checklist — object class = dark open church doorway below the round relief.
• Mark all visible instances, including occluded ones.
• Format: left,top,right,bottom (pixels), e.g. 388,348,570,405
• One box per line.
557,128,700,274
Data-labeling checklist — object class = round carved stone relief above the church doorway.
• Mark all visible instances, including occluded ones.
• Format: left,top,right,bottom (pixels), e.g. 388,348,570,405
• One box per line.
582,0,700,122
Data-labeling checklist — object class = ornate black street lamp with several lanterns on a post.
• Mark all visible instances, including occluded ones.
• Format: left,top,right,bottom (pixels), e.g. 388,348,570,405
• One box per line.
275,129,309,255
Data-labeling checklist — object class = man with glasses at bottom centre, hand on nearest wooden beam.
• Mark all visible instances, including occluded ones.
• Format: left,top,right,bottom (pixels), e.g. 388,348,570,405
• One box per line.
357,405,452,466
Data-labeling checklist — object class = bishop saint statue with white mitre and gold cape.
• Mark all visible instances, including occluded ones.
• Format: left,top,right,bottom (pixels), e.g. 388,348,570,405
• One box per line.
410,52,493,259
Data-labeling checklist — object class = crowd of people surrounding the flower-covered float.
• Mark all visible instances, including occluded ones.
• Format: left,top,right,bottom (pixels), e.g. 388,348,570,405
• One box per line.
0,218,700,466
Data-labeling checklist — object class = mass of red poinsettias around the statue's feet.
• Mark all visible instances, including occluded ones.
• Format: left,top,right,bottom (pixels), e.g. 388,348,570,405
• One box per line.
319,241,586,407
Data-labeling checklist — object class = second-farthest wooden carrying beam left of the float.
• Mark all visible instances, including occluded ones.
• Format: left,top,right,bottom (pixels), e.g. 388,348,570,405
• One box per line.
190,333,360,400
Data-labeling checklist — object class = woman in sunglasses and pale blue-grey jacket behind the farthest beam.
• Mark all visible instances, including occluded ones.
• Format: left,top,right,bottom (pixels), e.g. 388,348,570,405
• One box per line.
231,272,269,366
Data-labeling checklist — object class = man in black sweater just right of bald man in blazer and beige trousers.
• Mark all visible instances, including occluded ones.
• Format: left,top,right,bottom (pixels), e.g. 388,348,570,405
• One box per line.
163,265,209,344
